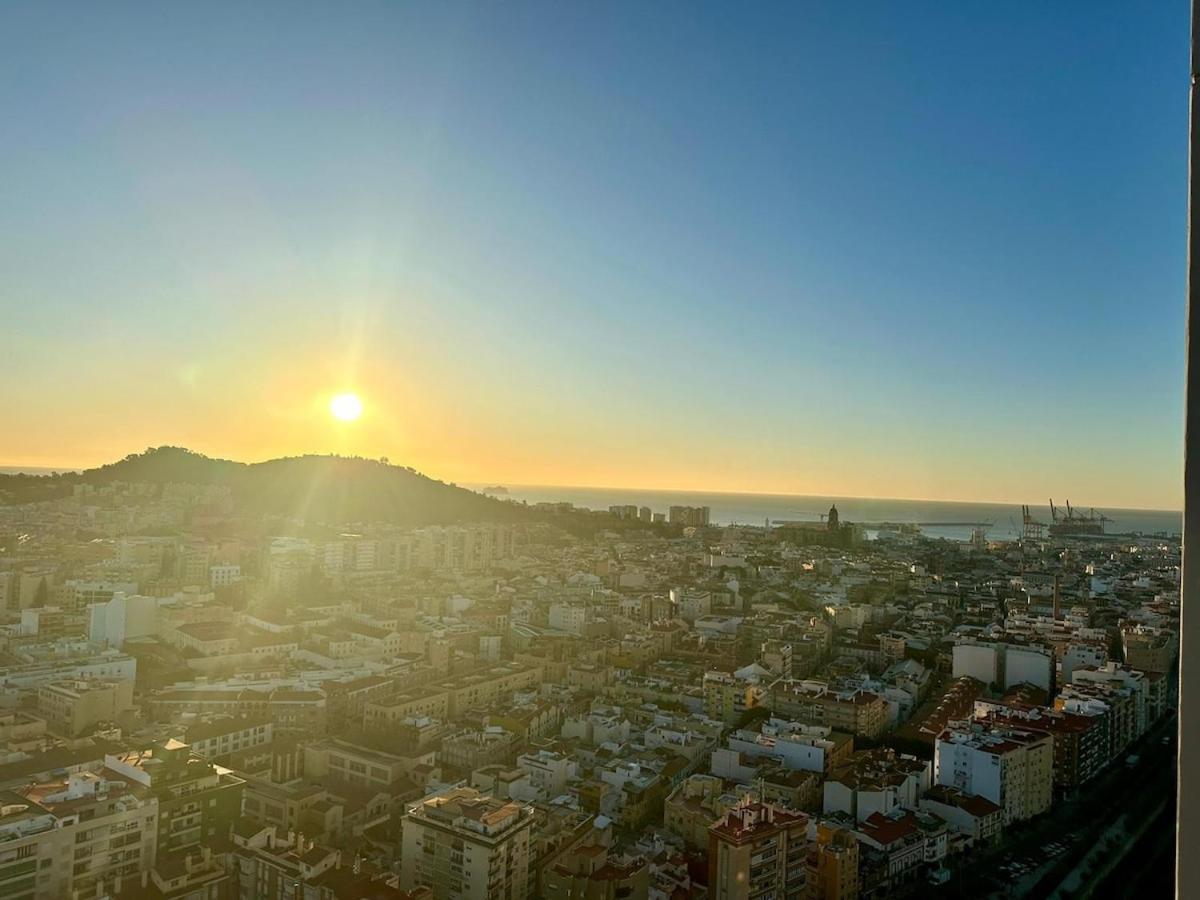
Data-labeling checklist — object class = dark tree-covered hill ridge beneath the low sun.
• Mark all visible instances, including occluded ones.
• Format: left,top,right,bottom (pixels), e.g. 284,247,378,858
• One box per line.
0,446,530,526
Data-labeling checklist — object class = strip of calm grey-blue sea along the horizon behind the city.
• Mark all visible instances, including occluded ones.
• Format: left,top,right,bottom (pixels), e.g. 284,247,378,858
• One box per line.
476,485,1183,541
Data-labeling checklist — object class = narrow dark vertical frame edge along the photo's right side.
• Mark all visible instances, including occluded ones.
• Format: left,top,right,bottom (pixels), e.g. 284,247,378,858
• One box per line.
1175,0,1200,898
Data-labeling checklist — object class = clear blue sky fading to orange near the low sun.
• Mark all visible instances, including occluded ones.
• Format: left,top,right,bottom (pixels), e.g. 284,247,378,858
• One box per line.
0,0,1188,506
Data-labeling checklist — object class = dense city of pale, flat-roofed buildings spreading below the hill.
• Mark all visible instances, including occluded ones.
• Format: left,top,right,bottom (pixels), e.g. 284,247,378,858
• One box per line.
0,455,1180,900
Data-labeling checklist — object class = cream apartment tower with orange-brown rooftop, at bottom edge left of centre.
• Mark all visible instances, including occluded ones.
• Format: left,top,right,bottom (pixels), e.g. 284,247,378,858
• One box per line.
400,787,534,900
